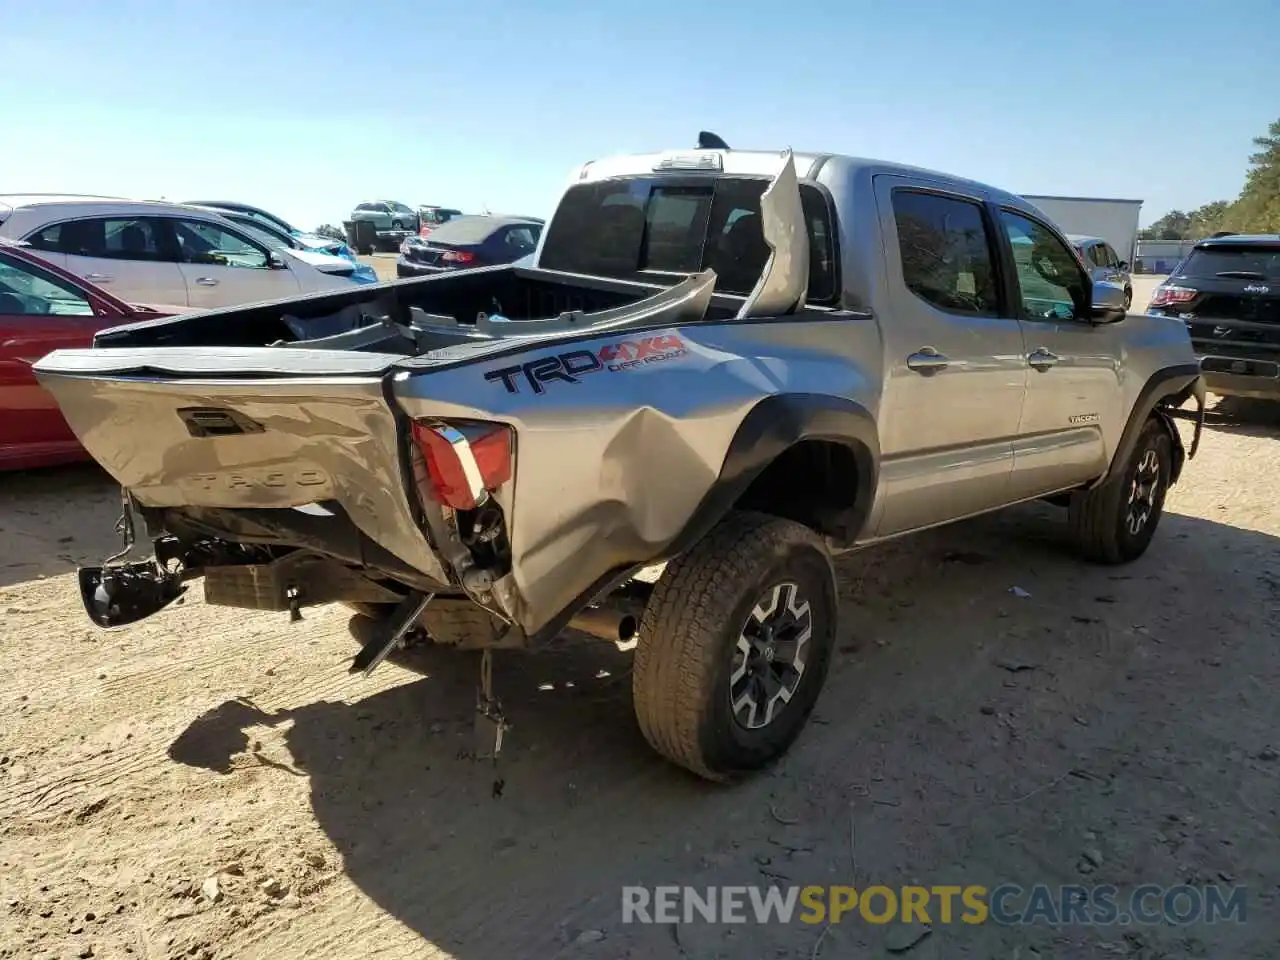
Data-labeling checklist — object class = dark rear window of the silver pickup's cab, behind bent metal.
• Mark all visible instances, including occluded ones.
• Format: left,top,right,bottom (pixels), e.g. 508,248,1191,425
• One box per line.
539,177,837,303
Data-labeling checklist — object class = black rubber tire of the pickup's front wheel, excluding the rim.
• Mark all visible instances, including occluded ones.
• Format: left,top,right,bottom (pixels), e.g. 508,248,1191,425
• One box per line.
1068,417,1174,564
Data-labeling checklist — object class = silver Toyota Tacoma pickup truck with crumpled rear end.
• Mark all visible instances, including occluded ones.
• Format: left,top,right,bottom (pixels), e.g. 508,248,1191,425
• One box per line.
36,135,1204,780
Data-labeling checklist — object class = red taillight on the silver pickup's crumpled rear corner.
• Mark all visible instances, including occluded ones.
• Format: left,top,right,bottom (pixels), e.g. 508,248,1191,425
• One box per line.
413,422,512,509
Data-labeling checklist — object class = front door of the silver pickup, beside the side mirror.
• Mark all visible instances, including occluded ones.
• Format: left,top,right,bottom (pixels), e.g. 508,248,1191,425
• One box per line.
998,209,1124,499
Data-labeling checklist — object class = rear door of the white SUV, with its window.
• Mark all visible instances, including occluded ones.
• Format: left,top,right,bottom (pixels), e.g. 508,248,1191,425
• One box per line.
27,216,187,306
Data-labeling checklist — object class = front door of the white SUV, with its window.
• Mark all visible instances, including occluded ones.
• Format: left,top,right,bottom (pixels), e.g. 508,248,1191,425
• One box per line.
164,216,301,310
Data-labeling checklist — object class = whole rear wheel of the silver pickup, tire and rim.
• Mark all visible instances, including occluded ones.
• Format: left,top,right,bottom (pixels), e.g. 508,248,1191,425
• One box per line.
632,513,838,781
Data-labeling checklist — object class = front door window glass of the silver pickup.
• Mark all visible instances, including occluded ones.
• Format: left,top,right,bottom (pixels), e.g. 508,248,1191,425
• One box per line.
1000,210,1089,320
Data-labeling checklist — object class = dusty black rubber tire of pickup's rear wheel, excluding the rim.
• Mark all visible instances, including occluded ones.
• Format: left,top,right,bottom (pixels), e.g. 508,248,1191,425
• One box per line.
632,512,838,781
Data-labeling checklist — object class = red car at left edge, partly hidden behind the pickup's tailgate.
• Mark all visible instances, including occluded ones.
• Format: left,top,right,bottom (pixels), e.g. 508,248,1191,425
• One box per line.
0,241,165,470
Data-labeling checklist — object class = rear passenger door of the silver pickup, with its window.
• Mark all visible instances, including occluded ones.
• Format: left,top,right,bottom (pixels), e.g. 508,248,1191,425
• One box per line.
876,175,1027,536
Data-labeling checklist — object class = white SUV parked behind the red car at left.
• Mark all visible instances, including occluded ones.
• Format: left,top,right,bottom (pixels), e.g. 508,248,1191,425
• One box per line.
0,195,355,310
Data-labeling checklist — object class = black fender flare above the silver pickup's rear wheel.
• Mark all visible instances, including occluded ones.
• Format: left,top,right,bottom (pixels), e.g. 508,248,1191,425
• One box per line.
663,393,879,557
